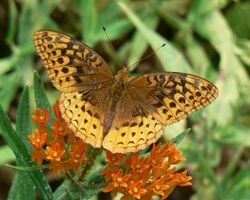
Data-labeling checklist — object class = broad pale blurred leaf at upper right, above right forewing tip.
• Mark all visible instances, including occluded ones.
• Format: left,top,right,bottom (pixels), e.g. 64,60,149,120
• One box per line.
194,12,249,86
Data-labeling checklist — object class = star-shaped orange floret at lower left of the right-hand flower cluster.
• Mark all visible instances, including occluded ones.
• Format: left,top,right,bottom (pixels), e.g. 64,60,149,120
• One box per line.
103,169,131,197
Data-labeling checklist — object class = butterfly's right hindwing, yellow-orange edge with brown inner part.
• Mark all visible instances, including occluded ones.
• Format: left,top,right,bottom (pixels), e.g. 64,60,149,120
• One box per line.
103,90,163,153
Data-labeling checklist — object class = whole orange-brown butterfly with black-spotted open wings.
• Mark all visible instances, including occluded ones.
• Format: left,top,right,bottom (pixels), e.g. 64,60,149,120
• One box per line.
34,30,218,153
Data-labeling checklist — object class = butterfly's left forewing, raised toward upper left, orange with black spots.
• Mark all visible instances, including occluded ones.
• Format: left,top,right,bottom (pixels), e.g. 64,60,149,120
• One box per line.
34,31,113,92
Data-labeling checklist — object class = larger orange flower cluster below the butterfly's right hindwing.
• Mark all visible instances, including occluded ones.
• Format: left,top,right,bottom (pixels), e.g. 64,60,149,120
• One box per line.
102,141,192,200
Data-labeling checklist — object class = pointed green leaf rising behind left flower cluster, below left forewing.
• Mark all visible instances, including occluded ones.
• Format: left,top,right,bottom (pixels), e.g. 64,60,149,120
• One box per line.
34,72,55,127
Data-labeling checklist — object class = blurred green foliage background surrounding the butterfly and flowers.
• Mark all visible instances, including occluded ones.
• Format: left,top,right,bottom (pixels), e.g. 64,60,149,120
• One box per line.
0,0,250,200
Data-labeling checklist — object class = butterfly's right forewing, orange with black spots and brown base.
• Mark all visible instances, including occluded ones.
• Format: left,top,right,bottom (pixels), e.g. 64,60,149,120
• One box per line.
131,72,218,125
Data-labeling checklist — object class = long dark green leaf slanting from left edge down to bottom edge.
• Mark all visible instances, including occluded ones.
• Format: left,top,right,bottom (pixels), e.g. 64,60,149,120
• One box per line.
0,107,52,199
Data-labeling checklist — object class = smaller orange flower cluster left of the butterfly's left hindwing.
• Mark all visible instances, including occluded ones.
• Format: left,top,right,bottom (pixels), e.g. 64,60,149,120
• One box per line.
29,102,88,175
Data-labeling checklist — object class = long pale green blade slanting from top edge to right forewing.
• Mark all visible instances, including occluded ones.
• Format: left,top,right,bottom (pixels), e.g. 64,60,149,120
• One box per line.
118,1,191,72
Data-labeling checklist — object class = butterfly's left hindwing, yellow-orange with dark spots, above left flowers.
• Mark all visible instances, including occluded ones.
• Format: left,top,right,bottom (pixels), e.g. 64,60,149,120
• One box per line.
59,88,111,147
